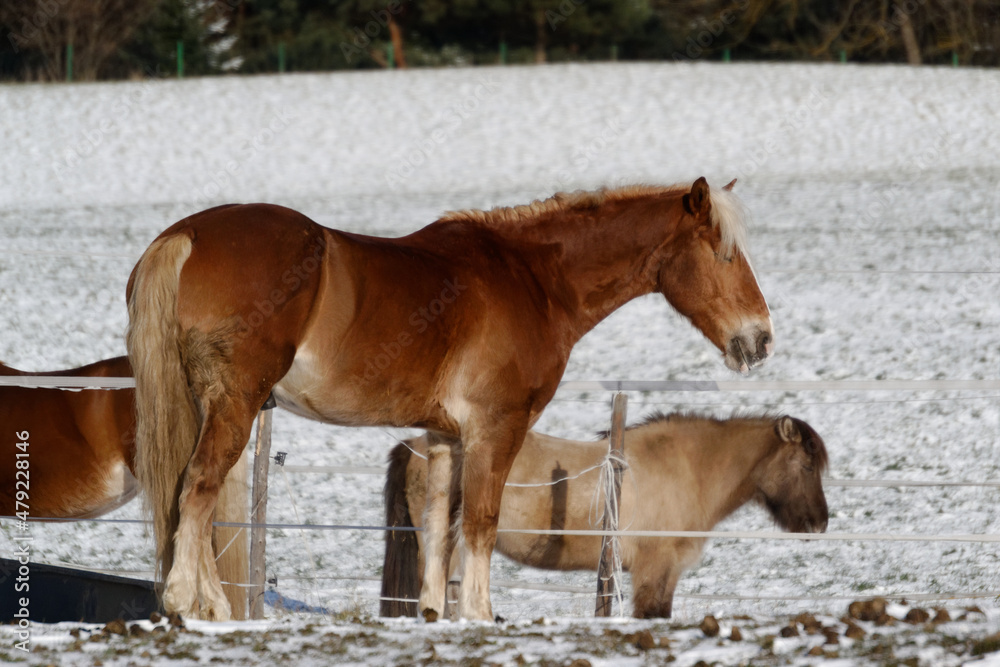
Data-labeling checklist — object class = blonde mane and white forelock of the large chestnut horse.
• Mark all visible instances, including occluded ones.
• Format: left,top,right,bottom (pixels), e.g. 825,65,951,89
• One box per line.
439,183,749,258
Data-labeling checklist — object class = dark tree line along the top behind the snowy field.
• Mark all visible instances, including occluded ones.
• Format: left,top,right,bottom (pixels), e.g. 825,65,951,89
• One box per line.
0,0,1000,81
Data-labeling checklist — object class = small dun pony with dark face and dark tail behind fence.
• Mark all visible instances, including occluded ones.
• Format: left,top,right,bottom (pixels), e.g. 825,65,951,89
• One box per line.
381,415,827,618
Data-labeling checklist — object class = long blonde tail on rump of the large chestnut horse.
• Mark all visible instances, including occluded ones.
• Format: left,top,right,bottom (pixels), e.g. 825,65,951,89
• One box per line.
125,234,201,580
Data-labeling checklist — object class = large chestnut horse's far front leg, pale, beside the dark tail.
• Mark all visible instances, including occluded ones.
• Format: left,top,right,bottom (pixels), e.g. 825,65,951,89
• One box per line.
418,433,461,623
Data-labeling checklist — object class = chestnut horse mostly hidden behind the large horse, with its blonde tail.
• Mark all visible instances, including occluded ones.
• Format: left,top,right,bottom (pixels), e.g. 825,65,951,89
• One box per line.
0,357,249,618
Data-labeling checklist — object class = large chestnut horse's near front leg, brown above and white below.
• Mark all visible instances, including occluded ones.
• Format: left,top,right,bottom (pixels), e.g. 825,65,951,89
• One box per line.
458,417,528,621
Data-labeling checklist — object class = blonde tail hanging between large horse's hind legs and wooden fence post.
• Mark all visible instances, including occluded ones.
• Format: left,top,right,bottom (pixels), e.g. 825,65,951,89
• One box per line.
213,451,250,621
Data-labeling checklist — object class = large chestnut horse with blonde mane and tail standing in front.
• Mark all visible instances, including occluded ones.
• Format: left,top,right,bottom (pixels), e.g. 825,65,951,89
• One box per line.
127,178,773,620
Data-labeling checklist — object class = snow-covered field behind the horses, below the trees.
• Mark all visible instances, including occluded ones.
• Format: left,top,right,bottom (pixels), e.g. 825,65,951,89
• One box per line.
0,63,1000,664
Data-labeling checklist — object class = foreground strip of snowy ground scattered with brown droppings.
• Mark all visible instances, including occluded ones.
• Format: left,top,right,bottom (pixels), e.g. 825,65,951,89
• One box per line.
9,605,1000,667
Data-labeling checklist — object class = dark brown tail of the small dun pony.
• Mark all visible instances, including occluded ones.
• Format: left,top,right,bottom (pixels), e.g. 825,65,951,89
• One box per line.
379,443,420,616
